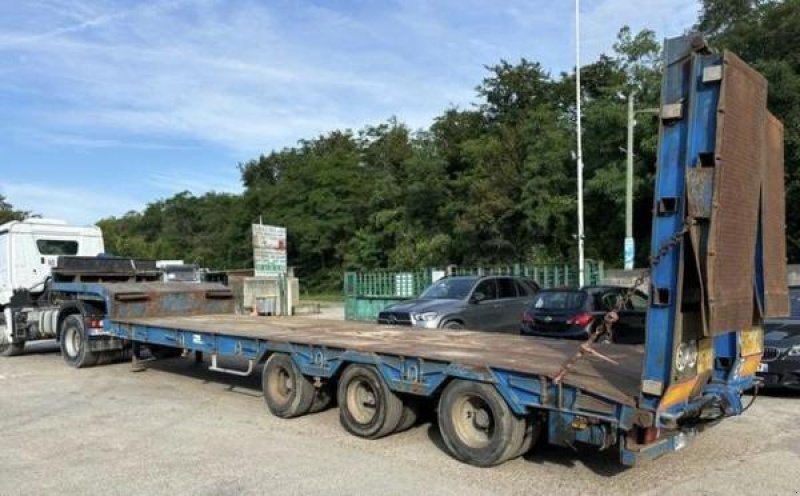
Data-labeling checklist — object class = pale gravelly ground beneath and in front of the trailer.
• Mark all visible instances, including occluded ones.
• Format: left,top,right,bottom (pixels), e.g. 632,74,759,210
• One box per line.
0,343,800,496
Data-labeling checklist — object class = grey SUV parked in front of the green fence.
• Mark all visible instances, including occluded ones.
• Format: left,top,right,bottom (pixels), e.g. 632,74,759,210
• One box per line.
378,276,539,332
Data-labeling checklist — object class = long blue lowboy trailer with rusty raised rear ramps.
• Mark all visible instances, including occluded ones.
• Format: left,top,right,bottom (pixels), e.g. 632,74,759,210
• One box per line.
12,36,788,466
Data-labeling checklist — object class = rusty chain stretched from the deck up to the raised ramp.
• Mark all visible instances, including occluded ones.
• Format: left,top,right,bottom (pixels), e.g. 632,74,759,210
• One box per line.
553,217,694,384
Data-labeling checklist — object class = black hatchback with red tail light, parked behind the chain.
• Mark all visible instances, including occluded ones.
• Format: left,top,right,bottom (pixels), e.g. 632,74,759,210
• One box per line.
520,286,647,344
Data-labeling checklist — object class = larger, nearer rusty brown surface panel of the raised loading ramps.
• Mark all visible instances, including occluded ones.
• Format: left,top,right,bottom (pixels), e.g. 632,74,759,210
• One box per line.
707,51,767,335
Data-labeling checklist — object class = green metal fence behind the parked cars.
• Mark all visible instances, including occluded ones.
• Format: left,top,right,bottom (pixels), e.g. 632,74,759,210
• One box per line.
344,260,605,321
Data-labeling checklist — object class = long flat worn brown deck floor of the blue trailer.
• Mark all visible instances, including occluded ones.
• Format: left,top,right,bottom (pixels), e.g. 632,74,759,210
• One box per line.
114,315,643,406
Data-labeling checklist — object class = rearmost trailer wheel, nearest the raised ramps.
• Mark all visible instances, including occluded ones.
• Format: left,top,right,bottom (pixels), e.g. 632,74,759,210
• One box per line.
439,380,526,467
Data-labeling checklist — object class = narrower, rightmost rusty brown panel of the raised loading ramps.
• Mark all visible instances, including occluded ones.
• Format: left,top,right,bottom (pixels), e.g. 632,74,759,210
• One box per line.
761,114,789,318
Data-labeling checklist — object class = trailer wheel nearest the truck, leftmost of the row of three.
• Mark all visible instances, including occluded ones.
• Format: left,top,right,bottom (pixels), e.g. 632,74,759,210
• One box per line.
261,353,316,418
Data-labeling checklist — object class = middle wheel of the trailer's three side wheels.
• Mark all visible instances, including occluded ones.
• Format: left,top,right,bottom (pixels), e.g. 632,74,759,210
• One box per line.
336,365,403,439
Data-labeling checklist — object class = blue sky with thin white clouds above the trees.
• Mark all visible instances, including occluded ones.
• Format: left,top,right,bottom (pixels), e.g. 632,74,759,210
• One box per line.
0,0,699,223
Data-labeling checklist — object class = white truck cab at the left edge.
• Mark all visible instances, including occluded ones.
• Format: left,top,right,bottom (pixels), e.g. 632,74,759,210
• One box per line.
0,219,104,308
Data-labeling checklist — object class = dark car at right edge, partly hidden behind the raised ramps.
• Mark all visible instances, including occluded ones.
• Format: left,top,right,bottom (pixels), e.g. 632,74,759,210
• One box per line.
758,286,800,389
